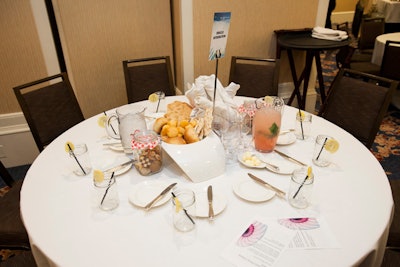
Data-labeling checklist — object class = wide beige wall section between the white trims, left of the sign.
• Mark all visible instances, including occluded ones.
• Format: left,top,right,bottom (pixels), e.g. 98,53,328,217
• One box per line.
54,0,172,117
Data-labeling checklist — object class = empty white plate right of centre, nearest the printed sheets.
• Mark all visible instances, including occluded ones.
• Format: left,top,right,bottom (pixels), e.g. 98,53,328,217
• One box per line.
233,178,275,202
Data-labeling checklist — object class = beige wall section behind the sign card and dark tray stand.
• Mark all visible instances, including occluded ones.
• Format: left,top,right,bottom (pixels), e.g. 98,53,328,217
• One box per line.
193,0,318,85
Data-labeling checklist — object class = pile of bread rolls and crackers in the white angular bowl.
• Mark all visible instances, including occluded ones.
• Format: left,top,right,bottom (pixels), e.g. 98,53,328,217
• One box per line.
153,101,212,145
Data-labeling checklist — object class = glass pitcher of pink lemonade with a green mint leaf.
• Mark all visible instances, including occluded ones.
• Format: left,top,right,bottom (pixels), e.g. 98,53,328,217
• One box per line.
253,96,285,153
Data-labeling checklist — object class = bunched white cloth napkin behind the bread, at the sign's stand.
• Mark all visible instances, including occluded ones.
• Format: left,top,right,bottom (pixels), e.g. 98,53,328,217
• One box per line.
185,74,240,120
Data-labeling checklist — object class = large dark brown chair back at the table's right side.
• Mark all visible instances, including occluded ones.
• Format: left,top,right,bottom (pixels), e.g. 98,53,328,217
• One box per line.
318,68,399,148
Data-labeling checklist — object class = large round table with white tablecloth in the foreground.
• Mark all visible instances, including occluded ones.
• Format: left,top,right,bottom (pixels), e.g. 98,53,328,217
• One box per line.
20,96,393,267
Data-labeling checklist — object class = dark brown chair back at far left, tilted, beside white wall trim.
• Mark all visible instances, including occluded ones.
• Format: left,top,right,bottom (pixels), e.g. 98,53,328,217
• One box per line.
14,72,84,151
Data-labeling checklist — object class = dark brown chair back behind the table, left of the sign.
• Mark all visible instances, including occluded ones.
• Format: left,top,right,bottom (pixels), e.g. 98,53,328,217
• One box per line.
122,56,175,103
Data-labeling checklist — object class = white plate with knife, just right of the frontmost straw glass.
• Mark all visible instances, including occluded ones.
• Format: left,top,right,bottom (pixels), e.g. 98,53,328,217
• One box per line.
188,192,227,218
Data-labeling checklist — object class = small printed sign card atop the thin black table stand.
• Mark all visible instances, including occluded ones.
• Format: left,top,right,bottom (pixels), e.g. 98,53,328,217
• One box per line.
208,12,231,60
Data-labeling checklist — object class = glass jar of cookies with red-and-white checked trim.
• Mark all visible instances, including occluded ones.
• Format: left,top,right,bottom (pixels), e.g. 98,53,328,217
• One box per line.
132,130,162,175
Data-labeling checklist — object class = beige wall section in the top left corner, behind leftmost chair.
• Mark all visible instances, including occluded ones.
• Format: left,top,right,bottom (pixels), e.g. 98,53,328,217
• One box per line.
0,0,47,114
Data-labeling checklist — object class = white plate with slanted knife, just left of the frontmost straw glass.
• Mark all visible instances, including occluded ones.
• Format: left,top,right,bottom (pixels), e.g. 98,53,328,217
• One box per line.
128,181,171,208
